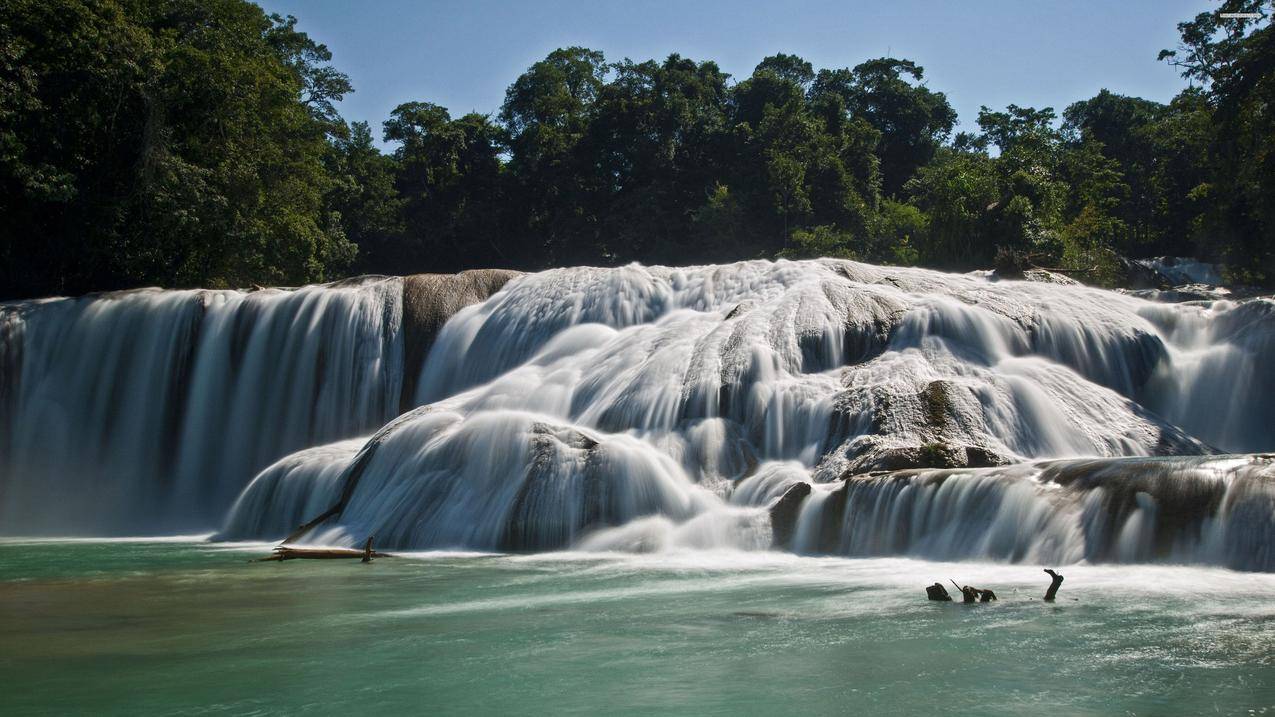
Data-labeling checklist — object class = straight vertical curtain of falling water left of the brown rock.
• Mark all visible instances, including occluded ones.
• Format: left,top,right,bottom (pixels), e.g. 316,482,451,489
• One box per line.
0,278,403,535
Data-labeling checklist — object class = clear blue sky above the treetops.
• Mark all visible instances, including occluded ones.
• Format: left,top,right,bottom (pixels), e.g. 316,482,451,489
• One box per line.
260,0,1216,146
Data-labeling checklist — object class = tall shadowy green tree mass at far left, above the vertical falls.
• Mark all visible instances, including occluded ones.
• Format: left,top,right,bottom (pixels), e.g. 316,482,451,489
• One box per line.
0,0,354,296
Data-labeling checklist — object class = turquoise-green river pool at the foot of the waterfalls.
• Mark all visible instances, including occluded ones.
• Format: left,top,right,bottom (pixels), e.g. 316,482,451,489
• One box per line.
0,541,1275,714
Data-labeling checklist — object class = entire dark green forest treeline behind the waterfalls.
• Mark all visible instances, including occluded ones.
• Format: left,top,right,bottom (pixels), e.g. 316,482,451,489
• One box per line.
0,0,1275,297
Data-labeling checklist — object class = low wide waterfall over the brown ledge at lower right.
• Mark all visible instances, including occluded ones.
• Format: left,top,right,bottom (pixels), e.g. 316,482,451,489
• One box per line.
798,455,1275,570
